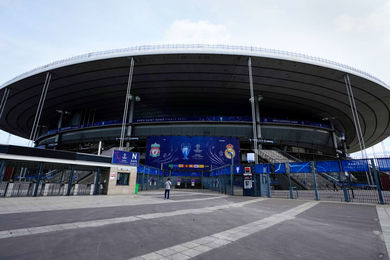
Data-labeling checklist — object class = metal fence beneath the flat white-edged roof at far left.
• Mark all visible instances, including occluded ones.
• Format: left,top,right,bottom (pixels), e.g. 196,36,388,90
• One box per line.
0,160,108,197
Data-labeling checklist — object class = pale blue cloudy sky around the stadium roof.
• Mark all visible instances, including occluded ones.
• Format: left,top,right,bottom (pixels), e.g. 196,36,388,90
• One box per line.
0,0,390,155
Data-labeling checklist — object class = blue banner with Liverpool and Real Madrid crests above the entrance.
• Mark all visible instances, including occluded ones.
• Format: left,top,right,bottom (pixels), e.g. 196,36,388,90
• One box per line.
146,136,240,170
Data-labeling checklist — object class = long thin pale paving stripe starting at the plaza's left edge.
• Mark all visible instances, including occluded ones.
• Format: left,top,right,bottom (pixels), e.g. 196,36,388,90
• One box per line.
0,198,265,239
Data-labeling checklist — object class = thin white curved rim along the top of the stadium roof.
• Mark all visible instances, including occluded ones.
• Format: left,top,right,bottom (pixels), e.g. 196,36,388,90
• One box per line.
0,44,390,90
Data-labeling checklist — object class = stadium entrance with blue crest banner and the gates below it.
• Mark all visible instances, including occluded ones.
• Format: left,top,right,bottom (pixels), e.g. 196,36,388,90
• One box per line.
138,136,256,196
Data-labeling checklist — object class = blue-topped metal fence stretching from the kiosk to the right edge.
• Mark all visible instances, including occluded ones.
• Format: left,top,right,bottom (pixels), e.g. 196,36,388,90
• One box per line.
255,158,390,204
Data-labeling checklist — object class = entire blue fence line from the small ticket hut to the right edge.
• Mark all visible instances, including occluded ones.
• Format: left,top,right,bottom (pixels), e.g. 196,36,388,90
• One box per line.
137,158,390,204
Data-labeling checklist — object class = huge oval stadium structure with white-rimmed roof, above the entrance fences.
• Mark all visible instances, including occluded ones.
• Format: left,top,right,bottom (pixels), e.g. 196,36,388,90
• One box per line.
0,45,390,167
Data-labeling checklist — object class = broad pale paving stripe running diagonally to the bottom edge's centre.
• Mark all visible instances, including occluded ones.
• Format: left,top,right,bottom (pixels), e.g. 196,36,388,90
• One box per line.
131,201,319,260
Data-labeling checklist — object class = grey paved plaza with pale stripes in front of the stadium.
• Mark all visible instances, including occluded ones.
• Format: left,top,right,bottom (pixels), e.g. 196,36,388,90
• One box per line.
0,190,390,260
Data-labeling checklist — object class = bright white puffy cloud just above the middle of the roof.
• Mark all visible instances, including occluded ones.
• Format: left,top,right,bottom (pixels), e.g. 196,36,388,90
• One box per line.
163,20,230,44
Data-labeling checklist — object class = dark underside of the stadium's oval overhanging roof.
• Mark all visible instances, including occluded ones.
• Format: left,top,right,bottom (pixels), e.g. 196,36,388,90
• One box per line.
0,46,390,152
